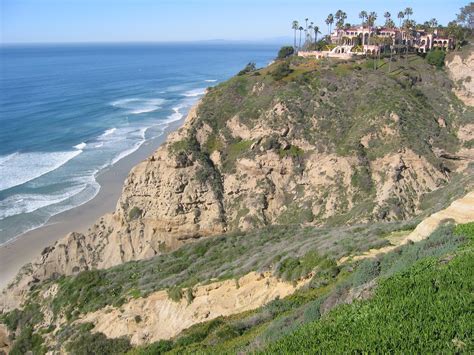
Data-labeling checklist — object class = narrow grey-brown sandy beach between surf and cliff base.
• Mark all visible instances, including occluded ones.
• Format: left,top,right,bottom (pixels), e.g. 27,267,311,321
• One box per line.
0,118,184,289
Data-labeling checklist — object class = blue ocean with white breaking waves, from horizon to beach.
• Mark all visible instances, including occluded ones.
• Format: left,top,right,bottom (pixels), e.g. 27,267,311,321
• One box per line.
0,43,277,244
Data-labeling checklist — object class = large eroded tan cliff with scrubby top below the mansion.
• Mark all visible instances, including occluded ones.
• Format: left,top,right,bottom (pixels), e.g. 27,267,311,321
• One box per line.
2,53,472,309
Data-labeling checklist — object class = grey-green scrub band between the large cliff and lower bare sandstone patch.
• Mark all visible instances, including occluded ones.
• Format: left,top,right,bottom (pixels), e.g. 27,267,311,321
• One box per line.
46,223,412,319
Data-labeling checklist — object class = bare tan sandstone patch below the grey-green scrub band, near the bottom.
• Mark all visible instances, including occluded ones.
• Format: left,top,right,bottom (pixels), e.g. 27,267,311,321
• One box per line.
78,272,311,345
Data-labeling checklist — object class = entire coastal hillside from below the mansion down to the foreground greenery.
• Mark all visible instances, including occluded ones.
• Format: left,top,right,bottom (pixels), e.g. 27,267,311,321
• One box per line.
0,49,474,353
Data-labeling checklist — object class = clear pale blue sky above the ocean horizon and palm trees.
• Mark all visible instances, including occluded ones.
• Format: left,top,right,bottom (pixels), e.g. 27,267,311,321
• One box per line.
0,0,468,44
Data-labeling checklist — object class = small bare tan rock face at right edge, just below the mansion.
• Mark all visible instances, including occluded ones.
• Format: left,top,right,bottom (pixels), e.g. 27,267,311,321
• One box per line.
446,50,474,106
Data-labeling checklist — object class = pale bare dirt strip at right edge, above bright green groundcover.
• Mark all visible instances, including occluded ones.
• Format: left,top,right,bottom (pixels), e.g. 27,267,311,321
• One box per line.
338,191,474,264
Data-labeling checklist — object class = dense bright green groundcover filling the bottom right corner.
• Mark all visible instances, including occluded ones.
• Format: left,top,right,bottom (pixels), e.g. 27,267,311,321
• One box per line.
265,224,474,353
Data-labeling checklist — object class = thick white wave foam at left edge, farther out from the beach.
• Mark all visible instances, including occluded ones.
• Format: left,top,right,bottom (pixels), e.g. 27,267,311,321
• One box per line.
0,149,82,191
